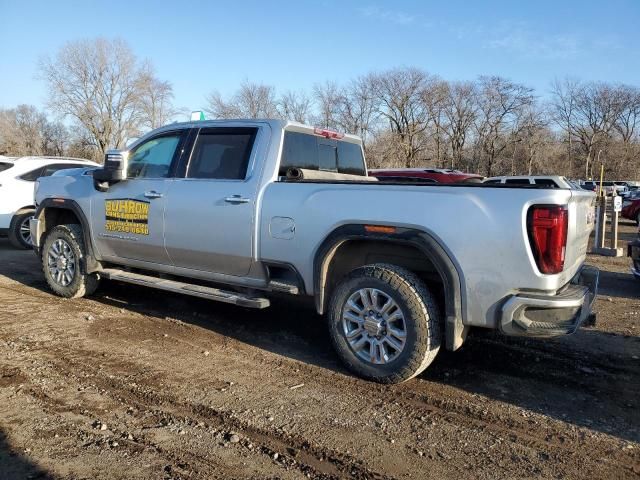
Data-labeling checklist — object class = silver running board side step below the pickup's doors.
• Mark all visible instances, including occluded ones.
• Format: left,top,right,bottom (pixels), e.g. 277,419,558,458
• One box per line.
100,268,270,308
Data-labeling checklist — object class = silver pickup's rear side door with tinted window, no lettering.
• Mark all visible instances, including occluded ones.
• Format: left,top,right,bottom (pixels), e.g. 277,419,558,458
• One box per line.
165,124,268,276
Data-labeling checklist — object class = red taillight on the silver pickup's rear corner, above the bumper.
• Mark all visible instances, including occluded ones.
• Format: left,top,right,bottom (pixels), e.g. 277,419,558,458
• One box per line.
527,205,569,274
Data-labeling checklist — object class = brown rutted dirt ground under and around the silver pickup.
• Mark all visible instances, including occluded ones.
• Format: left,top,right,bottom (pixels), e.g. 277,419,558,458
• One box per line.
0,224,640,480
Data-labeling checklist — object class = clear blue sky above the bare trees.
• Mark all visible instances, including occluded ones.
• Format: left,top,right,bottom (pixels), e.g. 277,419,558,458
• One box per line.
0,0,640,116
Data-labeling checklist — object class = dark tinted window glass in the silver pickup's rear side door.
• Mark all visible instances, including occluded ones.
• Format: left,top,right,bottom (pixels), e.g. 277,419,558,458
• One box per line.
187,128,257,180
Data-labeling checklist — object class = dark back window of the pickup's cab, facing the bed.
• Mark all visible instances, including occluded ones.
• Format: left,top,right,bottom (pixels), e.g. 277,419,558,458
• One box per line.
279,132,365,176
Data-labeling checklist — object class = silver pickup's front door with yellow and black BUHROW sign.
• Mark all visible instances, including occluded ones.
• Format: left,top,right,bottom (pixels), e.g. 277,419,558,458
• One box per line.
91,130,188,265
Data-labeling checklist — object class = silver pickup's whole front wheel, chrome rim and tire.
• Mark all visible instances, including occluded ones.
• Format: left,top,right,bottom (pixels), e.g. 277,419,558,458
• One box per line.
42,224,99,298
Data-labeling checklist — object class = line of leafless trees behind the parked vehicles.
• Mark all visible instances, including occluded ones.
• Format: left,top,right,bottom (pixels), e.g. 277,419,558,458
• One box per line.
0,39,640,179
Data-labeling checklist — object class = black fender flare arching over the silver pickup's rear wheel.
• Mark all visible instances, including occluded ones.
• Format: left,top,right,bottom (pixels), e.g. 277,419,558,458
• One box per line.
313,224,469,350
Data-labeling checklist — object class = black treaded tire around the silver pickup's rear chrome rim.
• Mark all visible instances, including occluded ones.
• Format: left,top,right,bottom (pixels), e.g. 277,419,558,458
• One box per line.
328,264,441,383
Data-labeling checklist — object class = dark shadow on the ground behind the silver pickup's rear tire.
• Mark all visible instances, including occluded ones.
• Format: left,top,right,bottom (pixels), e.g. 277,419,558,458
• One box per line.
419,328,640,442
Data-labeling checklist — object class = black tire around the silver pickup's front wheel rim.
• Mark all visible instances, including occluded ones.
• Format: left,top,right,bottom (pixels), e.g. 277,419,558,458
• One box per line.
41,224,99,298
